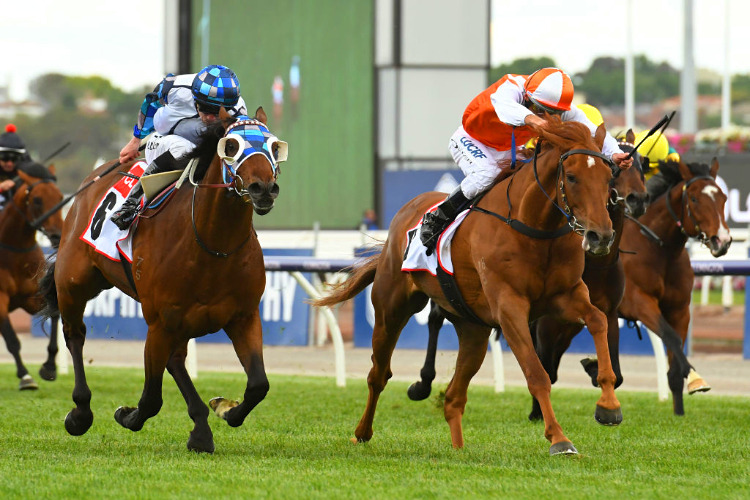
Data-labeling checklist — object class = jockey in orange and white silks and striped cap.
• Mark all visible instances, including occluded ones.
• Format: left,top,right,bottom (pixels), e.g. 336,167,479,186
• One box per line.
420,68,632,253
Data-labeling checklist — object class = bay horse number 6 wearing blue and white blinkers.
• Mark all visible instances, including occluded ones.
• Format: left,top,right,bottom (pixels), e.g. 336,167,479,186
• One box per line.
38,108,286,453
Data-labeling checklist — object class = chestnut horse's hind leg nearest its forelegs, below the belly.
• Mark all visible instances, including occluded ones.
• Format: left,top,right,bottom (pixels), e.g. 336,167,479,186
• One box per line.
443,323,490,448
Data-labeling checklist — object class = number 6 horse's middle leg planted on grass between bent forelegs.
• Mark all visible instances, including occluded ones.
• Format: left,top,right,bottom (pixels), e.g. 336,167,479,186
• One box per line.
167,343,214,453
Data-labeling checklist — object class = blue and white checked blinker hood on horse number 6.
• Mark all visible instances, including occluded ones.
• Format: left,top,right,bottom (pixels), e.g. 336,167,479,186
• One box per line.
217,116,289,183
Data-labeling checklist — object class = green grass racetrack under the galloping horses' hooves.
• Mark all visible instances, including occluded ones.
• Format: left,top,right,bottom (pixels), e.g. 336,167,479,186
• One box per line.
0,364,750,499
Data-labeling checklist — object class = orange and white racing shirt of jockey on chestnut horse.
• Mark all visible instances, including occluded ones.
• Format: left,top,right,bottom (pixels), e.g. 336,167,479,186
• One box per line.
462,74,622,158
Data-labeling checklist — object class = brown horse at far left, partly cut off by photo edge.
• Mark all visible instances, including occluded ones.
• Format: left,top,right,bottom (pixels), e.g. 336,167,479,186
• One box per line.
0,163,62,390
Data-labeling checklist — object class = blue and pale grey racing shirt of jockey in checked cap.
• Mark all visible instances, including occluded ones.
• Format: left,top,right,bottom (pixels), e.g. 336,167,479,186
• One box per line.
133,73,247,143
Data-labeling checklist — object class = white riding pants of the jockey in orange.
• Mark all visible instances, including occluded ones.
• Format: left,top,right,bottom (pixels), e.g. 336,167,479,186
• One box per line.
448,126,511,199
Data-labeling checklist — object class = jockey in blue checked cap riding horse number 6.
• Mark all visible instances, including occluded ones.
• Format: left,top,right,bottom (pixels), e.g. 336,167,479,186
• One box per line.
112,65,247,230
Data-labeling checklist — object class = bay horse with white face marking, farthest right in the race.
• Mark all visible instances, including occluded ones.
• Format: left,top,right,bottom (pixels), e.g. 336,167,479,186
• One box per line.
612,159,732,415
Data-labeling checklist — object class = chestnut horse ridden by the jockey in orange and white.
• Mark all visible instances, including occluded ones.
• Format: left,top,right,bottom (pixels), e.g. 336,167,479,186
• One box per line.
314,117,622,454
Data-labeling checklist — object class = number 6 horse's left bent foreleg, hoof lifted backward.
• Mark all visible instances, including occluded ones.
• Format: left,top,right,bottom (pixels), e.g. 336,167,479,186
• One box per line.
115,325,172,431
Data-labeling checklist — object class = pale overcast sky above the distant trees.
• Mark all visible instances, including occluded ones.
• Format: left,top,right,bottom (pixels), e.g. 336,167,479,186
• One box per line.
0,0,750,99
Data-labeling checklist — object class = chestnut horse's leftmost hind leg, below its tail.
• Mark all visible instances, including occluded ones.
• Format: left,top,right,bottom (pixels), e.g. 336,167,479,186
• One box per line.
352,284,427,443
